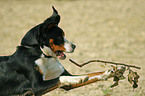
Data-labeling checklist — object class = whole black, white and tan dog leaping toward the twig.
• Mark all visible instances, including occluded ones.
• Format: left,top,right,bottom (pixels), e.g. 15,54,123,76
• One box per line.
0,6,116,96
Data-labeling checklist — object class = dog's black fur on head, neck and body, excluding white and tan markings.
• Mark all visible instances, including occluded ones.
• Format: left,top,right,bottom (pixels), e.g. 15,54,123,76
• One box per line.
0,7,71,96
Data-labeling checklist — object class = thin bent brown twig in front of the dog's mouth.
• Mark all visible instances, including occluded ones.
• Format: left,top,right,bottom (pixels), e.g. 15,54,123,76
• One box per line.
69,59,141,69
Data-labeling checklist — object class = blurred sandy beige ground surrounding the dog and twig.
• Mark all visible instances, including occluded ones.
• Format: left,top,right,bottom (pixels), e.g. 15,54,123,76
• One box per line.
0,0,145,96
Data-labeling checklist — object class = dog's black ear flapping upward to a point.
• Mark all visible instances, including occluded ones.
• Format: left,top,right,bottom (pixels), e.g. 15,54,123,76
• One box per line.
44,6,60,27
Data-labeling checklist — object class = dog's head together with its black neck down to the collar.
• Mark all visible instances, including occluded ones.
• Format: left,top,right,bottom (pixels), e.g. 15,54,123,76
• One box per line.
21,7,76,59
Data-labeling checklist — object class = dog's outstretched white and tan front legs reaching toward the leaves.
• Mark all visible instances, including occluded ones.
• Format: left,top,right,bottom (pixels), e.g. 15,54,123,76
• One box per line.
60,70,114,90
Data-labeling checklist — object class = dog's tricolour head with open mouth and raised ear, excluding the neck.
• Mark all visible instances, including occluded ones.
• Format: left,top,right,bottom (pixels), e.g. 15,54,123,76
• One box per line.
40,7,76,60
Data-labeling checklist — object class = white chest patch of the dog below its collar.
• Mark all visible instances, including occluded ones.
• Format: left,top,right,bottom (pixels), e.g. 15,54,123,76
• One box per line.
35,57,64,80
